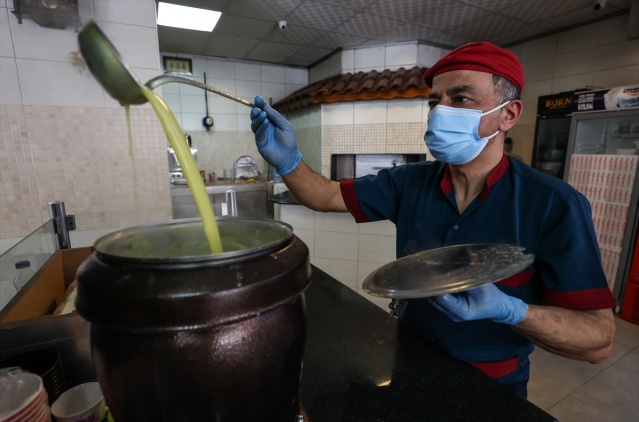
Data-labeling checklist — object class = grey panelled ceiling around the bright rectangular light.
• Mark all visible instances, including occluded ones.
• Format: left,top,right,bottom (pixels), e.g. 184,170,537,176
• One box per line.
156,0,632,67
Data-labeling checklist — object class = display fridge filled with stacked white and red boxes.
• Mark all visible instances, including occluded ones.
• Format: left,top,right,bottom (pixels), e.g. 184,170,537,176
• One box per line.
564,85,639,303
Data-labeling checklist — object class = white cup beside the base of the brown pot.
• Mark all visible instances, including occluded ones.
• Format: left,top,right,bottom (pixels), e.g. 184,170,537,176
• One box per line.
51,382,106,422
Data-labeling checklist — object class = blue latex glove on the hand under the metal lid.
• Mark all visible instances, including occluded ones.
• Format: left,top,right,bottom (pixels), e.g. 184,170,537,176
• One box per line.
431,284,528,325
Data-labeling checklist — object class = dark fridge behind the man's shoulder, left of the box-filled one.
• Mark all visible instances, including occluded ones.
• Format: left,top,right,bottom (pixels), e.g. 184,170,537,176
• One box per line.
532,91,576,178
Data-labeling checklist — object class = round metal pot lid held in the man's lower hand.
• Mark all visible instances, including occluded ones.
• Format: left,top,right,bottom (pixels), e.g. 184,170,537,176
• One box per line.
363,244,535,299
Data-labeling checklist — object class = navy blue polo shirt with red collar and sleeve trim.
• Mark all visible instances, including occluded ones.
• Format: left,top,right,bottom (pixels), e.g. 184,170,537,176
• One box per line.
341,155,616,394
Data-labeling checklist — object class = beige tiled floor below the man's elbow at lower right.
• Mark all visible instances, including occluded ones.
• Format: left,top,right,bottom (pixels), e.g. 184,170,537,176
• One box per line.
528,317,639,422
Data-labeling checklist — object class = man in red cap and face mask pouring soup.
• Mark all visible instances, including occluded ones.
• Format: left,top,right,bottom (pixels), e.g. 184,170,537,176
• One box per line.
251,42,616,397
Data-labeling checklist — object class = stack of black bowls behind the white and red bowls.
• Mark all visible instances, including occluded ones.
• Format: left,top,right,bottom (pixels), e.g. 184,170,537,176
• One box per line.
0,350,65,404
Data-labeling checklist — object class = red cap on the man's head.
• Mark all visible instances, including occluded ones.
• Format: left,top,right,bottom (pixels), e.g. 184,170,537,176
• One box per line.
424,42,524,92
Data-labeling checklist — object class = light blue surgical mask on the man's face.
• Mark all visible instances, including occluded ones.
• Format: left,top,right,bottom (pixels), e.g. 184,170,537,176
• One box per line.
424,101,510,165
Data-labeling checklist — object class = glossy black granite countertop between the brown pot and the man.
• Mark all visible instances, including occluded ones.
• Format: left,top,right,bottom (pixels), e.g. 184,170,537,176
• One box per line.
300,267,555,422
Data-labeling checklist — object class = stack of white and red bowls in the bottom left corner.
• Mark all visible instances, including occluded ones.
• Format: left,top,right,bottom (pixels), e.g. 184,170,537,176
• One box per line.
0,368,51,422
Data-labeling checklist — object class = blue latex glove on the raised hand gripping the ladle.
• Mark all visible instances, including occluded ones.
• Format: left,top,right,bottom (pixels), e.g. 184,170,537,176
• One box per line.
251,96,302,176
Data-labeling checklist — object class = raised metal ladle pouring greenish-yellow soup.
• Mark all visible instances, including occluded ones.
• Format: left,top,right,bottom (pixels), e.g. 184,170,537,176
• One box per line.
78,21,253,107
